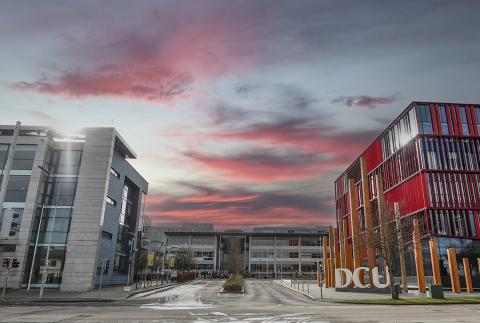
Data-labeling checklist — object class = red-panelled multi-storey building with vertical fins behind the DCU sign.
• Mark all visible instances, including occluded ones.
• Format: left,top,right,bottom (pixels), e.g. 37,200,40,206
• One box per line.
335,102,480,286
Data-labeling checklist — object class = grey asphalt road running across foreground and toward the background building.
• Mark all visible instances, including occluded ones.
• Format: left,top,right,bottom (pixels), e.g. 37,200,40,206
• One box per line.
0,280,480,323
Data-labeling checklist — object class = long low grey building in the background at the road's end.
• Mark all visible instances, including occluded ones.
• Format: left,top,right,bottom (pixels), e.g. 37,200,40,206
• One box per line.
160,227,327,278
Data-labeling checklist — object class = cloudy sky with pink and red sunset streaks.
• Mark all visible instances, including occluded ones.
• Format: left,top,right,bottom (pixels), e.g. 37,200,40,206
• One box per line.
0,0,480,229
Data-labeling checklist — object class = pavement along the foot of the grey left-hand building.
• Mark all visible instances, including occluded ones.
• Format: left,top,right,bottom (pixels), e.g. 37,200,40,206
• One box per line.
0,282,178,305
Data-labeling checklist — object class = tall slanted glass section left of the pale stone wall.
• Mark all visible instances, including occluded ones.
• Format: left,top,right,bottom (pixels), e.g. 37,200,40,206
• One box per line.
24,150,82,288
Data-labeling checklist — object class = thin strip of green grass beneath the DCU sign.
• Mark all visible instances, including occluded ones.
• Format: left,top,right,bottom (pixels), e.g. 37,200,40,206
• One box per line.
346,297,480,305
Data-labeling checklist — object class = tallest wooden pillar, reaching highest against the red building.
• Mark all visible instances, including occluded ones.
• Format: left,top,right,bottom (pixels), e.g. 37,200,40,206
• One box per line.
360,157,376,288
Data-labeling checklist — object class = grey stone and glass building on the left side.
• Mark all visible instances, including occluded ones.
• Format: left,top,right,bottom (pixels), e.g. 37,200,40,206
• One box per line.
0,123,148,291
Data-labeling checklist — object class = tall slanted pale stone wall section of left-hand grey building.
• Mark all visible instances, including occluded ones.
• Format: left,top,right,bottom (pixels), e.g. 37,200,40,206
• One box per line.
60,128,115,291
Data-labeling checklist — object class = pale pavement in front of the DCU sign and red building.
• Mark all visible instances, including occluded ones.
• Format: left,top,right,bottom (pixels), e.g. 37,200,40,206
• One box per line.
275,279,479,302
